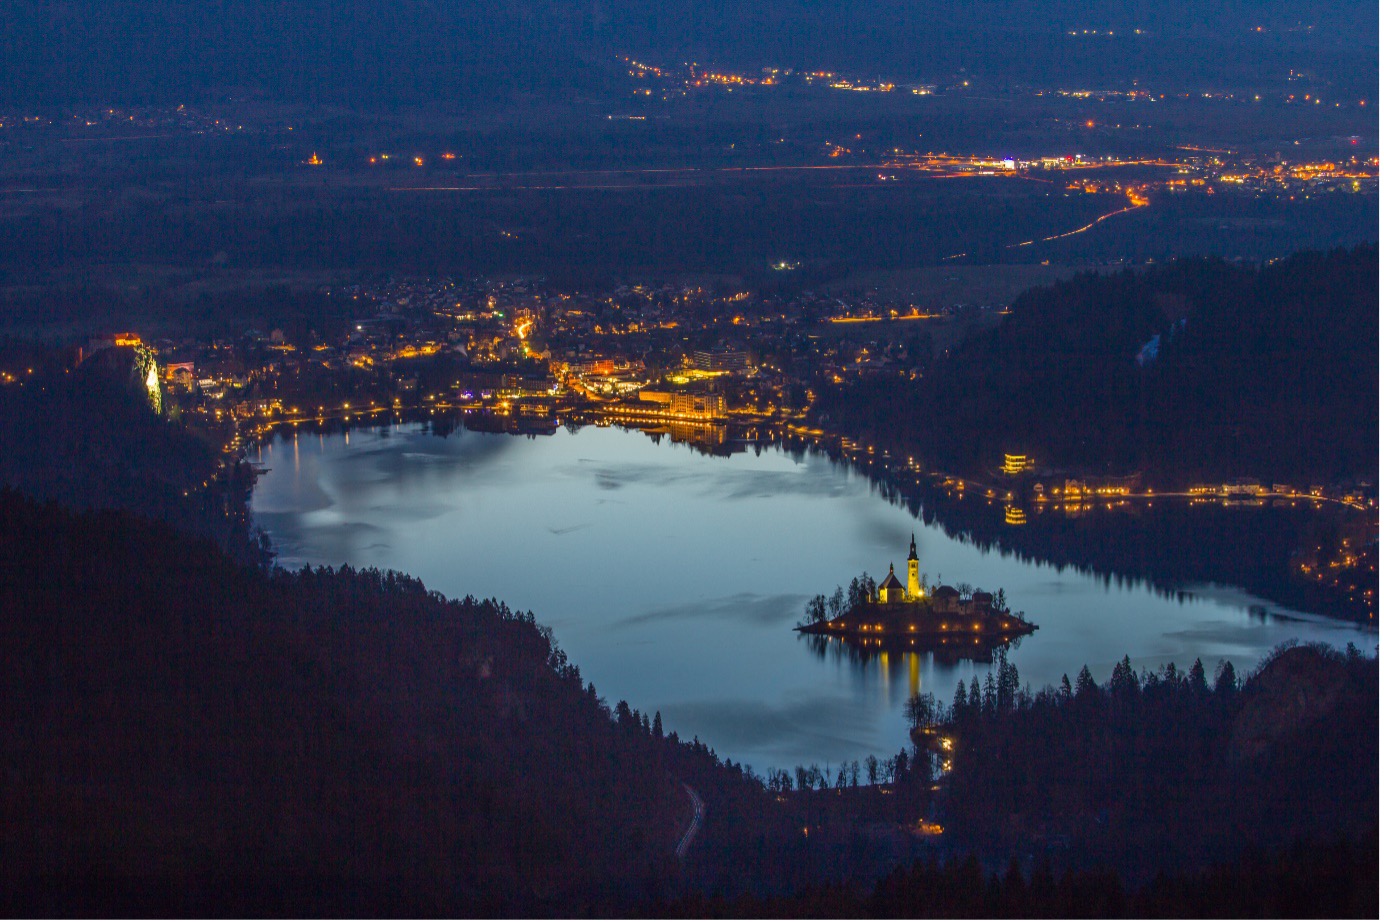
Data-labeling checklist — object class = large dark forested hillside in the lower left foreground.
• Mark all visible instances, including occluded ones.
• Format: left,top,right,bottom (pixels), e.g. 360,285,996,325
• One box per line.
0,491,775,915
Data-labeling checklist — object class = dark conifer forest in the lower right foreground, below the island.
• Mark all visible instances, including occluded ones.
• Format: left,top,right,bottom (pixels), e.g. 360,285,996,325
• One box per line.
659,644,1378,918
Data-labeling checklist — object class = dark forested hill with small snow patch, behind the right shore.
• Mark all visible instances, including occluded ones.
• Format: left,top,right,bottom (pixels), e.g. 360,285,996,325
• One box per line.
815,245,1378,487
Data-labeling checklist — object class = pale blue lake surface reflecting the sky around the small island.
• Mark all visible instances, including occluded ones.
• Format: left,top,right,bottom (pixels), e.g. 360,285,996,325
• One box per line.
251,425,1377,772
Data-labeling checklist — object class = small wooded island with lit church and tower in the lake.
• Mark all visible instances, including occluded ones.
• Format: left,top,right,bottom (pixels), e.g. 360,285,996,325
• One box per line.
797,536,1038,647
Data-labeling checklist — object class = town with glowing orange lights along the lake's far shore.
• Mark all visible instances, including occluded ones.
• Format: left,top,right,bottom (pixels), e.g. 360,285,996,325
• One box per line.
24,249,1377,624
